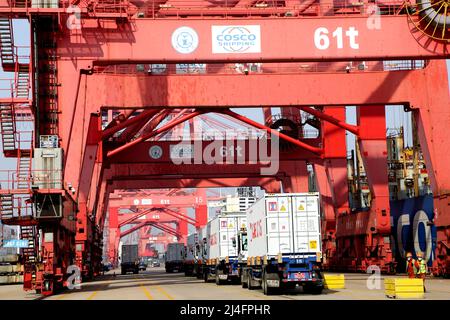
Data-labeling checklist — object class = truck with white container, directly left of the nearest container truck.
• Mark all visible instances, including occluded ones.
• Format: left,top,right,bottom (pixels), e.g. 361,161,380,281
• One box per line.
203,212,247,285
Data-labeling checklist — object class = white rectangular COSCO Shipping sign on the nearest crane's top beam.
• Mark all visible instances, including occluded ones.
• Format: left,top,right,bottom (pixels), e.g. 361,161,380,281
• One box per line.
211,26,261,53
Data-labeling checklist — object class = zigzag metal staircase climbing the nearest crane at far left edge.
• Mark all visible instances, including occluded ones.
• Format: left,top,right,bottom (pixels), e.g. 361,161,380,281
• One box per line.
0,11,38,291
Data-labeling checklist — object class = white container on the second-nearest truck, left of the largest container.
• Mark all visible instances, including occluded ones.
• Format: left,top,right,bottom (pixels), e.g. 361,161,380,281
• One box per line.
207,212,247,259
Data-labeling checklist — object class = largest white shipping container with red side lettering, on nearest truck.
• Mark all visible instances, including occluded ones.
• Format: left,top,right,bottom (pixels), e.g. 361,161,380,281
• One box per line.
247,193,321,257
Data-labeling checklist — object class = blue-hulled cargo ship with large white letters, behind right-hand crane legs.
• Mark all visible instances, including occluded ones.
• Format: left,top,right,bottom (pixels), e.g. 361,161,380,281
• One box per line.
348,127,437,273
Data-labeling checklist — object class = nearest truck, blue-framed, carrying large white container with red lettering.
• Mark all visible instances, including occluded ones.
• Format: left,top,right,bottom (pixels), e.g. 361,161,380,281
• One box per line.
241,193,323,295
